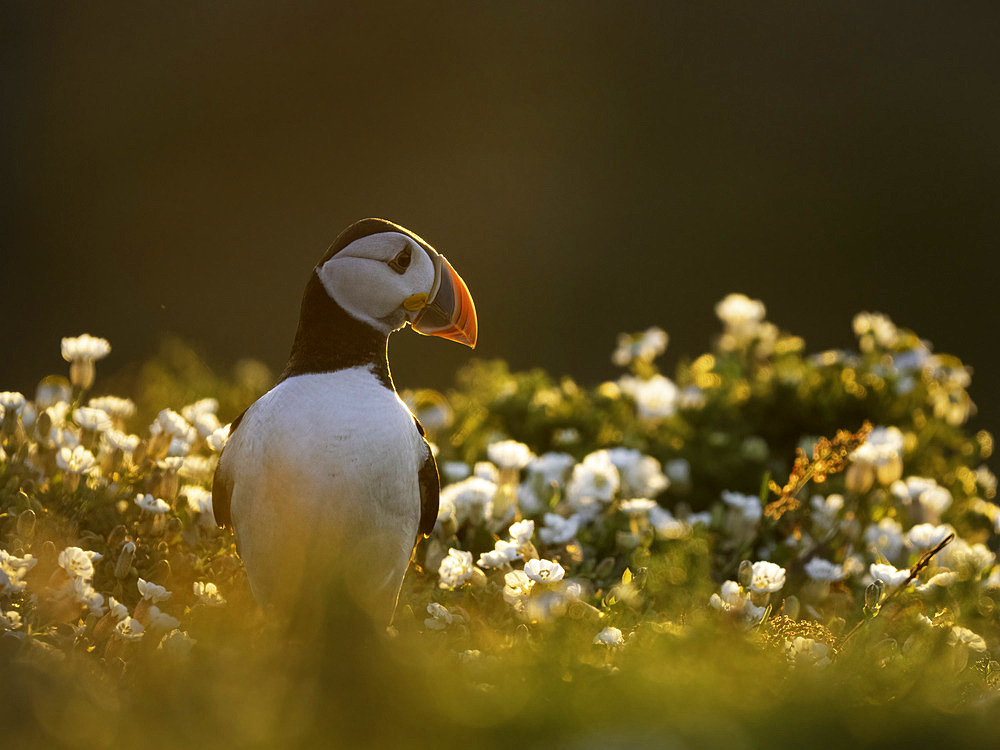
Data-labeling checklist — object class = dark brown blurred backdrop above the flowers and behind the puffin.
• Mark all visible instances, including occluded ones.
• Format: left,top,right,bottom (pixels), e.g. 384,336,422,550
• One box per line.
0,0,1000,428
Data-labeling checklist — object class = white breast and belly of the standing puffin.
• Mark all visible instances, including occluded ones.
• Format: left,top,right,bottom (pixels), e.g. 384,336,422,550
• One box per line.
222,367,426,620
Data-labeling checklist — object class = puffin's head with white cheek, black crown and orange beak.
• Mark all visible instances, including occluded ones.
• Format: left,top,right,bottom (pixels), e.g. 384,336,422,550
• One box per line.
316,219,477,348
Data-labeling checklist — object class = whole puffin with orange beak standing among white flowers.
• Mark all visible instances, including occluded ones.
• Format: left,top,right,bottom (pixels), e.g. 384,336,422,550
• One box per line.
212,218,478,624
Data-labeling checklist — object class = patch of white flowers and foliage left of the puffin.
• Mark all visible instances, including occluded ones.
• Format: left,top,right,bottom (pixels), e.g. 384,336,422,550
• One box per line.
0,334,241,657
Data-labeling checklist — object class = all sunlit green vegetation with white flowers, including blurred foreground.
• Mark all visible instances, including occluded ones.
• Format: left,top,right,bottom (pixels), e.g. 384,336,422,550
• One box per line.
0,295,1000,748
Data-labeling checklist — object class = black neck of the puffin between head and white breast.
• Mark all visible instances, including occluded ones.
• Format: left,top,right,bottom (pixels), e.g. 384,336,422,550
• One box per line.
278,269,395,390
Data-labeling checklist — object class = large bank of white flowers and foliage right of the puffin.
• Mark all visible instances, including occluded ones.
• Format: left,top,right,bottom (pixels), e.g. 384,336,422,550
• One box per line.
409,295,1000,666
